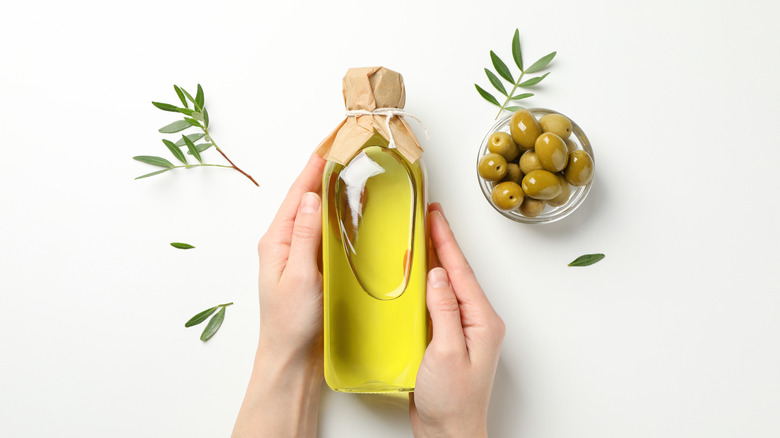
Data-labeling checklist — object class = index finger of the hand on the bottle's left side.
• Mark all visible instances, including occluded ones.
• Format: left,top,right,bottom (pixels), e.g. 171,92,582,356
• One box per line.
268,154,326,245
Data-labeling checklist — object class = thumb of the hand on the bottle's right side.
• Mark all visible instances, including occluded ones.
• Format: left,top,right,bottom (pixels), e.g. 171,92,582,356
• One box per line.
425,268,466,354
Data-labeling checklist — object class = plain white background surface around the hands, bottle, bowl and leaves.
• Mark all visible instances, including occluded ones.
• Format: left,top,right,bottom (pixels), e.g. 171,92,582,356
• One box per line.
0,0,780,438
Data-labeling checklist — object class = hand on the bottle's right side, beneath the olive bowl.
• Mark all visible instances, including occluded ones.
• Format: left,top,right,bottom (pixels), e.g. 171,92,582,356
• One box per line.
409,204,506,438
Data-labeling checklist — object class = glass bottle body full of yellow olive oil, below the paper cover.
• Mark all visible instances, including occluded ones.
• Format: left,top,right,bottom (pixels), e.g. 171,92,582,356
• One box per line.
322,132,428,392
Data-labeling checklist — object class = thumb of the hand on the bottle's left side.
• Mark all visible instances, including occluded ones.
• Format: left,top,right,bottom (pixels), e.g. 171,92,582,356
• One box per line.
285,192,322,273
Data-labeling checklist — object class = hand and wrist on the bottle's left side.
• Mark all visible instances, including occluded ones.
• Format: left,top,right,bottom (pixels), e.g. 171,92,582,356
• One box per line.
233,155,325,438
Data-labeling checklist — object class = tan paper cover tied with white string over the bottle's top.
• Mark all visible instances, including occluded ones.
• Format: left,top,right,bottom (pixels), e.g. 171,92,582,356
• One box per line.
316,67,423,165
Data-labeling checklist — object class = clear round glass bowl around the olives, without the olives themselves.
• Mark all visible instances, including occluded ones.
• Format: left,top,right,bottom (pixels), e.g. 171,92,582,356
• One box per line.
477,108,596,224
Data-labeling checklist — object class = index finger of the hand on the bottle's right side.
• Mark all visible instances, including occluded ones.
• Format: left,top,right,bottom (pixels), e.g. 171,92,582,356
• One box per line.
430,206,492,309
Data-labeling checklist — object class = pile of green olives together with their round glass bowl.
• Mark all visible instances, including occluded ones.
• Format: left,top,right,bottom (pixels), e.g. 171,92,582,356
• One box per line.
477,108,596,224
